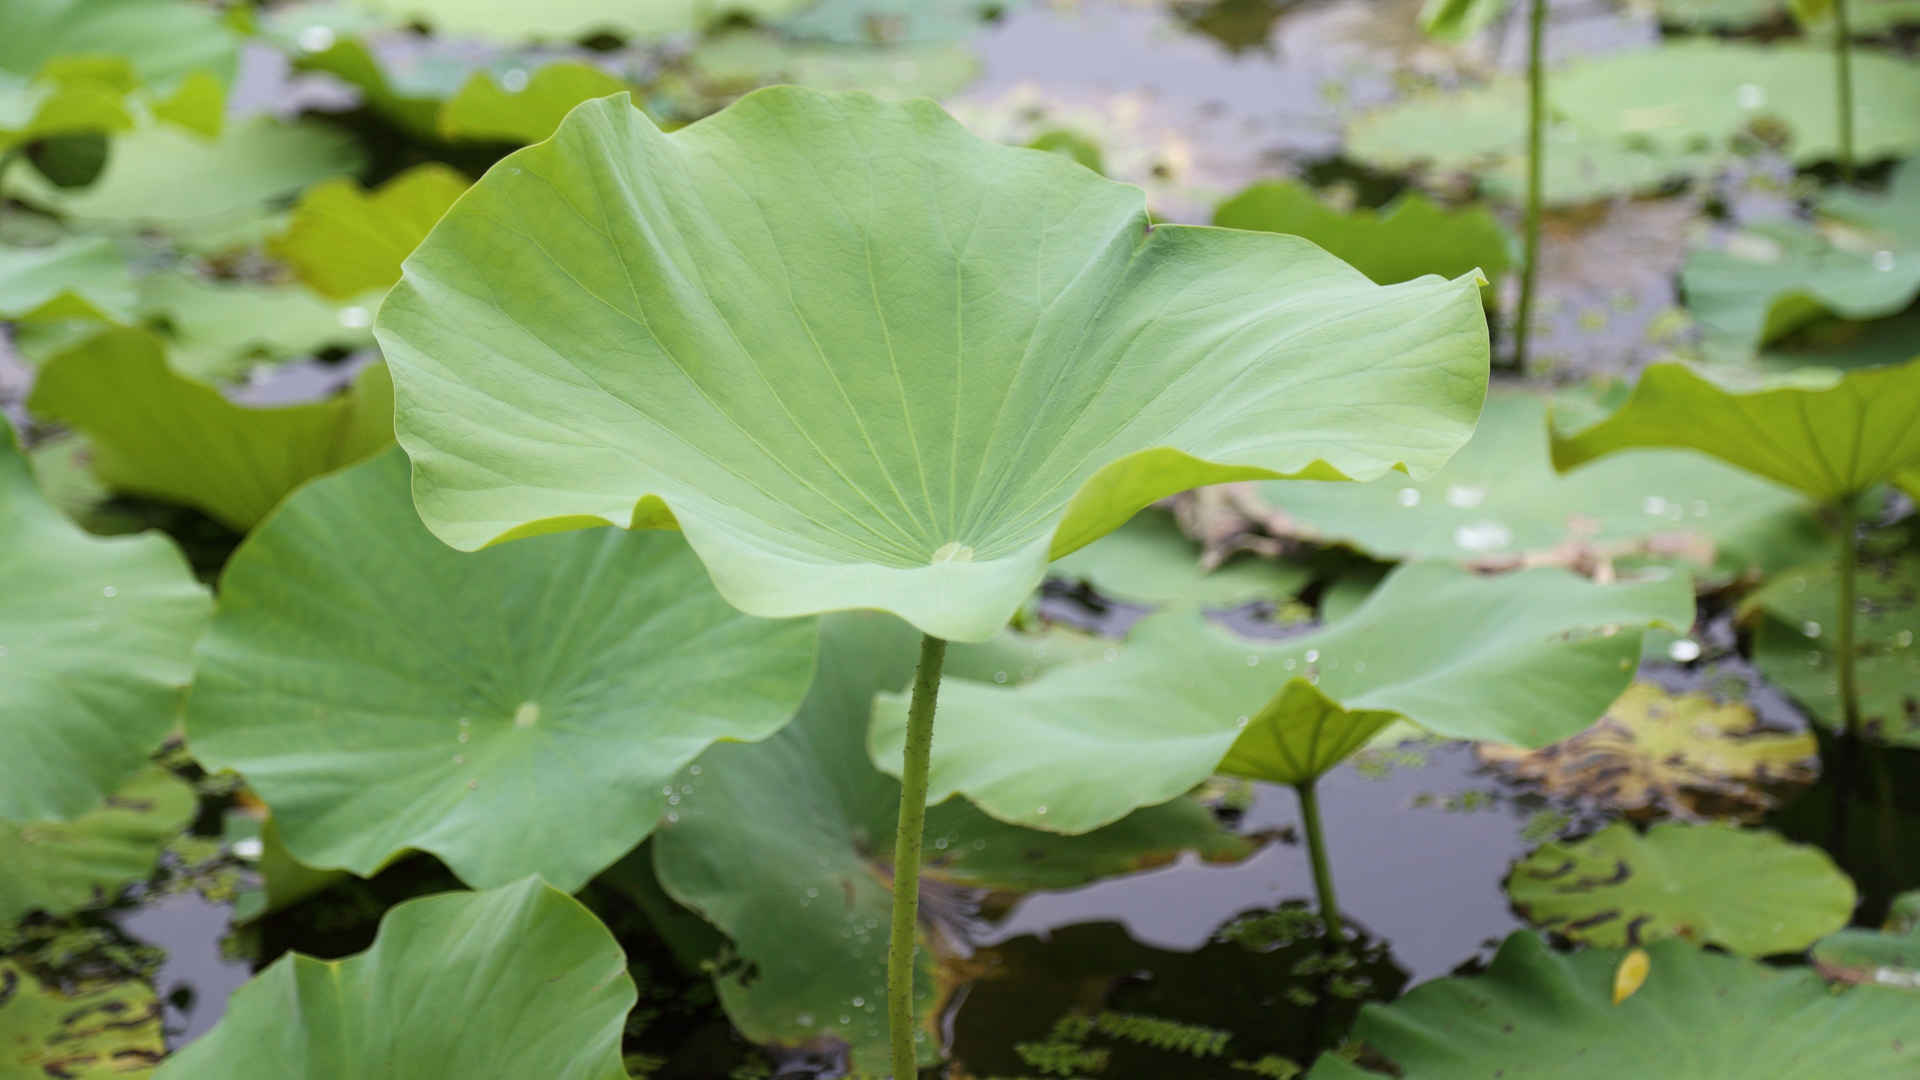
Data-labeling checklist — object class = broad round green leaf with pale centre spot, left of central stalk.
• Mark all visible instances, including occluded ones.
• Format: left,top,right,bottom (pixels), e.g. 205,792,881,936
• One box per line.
186,452,814,890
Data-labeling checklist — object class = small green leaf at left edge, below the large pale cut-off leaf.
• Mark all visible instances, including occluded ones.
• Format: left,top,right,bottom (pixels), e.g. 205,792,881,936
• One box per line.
0,767,196,922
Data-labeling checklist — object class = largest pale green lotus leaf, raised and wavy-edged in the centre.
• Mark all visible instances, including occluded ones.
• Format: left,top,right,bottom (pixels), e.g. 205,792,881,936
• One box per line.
374,88,1486,640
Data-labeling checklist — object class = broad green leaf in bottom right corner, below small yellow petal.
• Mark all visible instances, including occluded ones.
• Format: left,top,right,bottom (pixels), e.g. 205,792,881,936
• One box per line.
1309,932,1920,1080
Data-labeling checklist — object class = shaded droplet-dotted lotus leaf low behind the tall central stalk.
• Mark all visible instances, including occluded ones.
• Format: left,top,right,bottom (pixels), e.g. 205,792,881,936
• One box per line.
645,613,1250,1068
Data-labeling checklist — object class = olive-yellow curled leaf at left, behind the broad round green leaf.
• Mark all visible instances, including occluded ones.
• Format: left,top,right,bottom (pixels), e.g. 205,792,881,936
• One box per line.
29,329,392,532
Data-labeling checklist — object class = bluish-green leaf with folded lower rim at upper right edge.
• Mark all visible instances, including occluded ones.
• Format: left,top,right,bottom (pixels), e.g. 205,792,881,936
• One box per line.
1680,161,1920,359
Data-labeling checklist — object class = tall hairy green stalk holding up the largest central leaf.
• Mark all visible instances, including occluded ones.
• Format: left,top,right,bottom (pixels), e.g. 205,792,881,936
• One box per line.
887,634,947,1080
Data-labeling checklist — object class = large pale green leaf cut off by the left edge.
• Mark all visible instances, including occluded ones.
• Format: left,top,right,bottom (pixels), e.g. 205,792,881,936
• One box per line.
0,411,209,821
